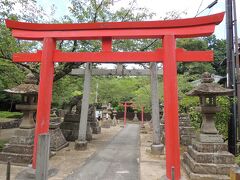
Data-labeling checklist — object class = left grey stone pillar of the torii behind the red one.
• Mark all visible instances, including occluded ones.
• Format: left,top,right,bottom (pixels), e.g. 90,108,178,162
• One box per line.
75,63,91,150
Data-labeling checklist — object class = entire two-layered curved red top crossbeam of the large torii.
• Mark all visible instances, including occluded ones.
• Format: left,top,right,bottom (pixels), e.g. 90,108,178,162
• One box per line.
6,13,224,40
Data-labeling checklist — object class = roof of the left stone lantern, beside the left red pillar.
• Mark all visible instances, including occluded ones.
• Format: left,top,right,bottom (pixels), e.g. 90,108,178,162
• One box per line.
4,73,38,95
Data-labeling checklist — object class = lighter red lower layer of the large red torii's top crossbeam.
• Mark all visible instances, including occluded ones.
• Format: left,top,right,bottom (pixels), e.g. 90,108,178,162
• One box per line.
12,24,215,40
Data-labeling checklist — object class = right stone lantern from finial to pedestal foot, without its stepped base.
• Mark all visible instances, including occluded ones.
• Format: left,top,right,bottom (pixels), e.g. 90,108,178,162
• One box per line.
187,72,233,142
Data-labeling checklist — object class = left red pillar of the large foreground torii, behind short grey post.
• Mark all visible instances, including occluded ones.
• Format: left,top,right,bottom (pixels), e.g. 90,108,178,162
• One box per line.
32,38,56,169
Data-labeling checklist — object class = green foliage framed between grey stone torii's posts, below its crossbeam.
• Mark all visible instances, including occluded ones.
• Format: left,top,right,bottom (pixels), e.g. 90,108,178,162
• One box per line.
91,77,149,108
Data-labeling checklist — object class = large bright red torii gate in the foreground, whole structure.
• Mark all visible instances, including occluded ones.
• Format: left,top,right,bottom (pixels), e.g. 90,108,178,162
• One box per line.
6,13,224,179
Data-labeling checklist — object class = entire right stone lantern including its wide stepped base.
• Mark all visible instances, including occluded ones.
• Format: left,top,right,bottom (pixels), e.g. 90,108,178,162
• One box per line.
183,73,236,180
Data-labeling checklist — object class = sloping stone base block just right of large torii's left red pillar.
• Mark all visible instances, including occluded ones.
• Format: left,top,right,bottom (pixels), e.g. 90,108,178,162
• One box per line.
49,127,69,151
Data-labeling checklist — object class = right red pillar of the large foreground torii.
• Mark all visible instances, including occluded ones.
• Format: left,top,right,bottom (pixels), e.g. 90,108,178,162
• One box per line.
163,36,180,180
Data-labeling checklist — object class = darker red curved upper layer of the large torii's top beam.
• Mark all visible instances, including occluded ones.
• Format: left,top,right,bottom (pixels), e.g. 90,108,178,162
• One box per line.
6,12,224,31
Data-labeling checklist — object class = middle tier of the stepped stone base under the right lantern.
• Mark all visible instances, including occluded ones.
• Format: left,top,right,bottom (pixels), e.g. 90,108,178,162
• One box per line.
188,146,235,164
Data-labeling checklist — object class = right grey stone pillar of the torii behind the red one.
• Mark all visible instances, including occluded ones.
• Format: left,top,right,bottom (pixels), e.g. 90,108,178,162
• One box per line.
150,62,164,154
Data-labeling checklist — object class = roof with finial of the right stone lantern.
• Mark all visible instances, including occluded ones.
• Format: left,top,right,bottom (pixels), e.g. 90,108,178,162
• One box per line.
187,72,233,96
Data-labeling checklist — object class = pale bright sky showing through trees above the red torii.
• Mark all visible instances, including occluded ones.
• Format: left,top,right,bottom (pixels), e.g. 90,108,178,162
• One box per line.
38,0,240,39
